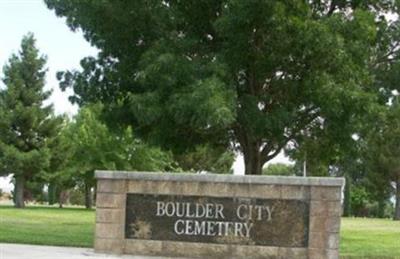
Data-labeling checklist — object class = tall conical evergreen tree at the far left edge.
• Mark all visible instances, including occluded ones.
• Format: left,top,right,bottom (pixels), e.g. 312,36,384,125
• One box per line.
0,34,58,208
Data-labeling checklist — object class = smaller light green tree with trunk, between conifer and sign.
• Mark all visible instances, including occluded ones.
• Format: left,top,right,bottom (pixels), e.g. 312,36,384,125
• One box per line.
54,104,175,208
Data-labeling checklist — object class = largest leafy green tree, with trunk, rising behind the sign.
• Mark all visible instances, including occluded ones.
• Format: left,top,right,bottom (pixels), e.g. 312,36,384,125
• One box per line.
45,0,398,174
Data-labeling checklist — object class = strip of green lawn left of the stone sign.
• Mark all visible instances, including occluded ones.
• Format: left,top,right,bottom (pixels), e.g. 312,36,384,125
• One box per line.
0,206,95,247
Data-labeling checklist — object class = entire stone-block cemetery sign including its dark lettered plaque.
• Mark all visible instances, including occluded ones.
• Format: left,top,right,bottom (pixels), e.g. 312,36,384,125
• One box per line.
94,171,344,259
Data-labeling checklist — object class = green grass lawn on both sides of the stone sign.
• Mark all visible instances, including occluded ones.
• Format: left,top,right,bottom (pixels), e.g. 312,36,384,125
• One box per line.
0,206,400,259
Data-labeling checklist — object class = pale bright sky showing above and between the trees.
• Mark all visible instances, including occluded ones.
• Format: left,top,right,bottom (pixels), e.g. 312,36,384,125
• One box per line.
0,0,288,191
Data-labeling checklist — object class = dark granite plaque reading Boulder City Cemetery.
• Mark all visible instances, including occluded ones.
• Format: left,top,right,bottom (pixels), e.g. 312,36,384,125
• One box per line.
125,193,309,247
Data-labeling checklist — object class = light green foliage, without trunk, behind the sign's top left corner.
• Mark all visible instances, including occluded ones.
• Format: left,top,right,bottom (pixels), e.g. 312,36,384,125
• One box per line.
64,104,173,178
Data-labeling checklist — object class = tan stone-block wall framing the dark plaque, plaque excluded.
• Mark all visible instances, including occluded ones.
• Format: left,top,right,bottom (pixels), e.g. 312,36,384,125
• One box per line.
95,171,344,259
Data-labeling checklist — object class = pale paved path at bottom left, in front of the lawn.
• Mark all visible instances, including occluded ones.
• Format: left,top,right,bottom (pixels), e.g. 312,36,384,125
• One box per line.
0,243,178,259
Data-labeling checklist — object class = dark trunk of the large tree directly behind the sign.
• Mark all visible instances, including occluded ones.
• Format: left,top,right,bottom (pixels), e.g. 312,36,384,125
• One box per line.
243,143,264,175
